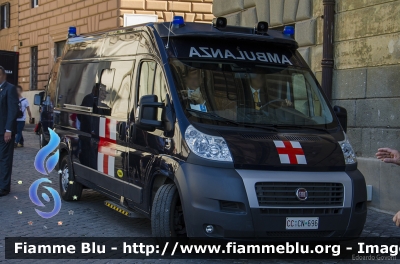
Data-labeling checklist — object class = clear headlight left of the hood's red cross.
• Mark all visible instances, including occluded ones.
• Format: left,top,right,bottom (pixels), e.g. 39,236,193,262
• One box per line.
185,125,232,162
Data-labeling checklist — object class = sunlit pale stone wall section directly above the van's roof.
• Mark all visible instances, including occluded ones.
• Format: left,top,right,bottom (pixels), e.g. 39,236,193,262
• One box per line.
119,0,214,26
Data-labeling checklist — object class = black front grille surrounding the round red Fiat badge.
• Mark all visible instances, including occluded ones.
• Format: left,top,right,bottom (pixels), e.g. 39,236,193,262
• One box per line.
255,182,344,207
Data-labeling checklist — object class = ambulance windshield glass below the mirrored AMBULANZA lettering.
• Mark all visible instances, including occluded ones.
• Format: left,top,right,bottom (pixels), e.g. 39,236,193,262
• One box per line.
170,58,336,128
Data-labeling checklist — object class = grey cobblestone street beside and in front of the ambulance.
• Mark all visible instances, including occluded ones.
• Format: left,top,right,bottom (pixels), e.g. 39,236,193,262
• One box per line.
0,128,400,263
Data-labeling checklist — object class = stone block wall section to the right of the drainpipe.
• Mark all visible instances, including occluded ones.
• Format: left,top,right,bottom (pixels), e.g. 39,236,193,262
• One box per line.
333,0,400,212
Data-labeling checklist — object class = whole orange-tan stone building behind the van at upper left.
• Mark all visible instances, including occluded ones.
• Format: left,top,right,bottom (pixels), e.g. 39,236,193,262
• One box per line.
0,0,214,120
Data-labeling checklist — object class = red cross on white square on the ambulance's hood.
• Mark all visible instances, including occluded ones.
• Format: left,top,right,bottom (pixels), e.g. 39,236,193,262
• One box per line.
274,140,307,164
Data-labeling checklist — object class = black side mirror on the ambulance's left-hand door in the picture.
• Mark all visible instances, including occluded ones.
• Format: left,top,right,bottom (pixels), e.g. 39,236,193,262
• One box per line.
135,95,164,131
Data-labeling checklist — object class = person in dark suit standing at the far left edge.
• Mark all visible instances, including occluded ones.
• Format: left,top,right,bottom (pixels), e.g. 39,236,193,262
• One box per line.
0,66,18,196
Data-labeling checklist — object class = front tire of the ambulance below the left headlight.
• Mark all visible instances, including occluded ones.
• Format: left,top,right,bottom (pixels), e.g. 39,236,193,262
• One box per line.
151,184,186,237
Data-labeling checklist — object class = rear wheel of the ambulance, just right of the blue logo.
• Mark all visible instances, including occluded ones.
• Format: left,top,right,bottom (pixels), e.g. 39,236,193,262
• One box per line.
59,155,83,201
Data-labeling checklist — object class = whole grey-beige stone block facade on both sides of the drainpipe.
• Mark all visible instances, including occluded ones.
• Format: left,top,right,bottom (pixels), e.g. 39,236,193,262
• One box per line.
213,0,400,212
